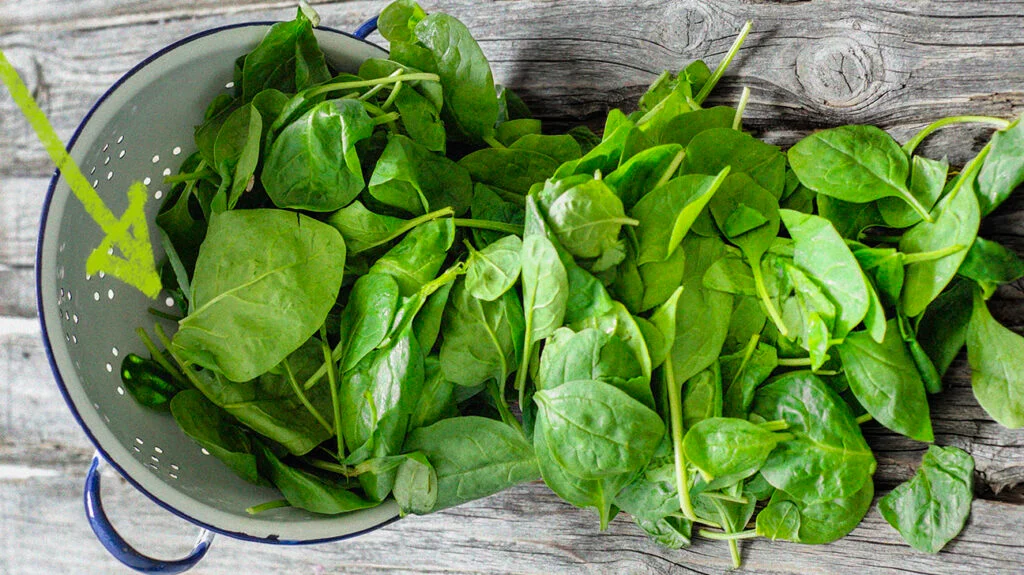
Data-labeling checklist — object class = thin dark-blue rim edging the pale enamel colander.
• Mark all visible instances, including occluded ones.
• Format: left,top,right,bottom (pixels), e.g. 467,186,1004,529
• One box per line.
36,16,399,545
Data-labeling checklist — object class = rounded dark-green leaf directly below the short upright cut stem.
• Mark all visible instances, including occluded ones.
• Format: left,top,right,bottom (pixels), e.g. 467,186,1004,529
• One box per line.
682,126,785,196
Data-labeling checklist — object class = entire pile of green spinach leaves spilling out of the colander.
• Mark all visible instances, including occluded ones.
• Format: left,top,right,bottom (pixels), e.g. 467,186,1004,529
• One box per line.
122,0,1024,565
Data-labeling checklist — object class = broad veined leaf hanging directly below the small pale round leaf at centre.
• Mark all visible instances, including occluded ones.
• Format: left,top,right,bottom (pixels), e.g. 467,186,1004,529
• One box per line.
440,280,525,387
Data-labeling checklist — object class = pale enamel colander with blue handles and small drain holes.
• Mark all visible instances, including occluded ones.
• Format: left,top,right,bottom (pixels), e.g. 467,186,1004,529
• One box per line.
36,14,398,573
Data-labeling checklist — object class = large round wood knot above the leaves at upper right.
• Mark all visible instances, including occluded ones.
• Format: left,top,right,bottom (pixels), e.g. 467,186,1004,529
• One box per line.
797,31,885,107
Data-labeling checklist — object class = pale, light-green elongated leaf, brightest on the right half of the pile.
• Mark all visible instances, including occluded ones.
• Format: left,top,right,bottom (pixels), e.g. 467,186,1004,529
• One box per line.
779,210,870,338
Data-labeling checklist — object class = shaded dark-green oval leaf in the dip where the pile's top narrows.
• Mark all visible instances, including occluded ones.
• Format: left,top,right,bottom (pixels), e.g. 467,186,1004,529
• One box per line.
459,147,558,195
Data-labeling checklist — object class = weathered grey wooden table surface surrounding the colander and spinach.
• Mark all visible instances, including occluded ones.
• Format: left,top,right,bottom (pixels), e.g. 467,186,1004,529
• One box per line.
0,0,1024,575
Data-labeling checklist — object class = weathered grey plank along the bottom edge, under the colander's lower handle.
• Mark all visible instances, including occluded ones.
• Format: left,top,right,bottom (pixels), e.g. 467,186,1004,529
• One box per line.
0,466,1024,575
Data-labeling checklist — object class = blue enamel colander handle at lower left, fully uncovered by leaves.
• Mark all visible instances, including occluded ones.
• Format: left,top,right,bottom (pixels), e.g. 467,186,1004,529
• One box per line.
85,453,213,574
